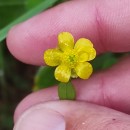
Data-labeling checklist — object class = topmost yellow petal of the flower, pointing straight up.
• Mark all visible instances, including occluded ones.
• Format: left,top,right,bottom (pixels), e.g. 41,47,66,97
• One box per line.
58,32,74,51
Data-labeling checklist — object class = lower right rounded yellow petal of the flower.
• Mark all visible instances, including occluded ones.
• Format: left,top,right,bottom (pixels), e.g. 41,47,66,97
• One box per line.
75,62,93,79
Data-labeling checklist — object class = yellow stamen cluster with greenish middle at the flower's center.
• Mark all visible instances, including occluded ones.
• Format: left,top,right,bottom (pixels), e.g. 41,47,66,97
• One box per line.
62,49,77,68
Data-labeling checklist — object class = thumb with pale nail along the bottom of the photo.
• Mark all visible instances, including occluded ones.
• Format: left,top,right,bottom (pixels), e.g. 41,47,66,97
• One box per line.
14,101,130,130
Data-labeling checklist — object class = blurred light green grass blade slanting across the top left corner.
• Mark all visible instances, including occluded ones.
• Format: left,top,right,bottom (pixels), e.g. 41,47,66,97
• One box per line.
0,0,58,41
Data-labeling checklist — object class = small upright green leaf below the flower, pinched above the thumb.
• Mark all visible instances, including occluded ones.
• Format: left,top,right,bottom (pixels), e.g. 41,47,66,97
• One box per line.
58,82,76,100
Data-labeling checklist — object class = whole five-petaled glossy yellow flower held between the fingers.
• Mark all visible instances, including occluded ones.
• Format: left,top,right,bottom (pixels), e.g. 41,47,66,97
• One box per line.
44,32,96,82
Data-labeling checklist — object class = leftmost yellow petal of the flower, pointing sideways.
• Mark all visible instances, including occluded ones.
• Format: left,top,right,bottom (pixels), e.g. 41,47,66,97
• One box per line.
44,49,61,66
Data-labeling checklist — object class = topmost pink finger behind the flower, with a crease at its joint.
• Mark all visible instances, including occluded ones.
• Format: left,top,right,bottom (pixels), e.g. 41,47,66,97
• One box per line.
7,0,130,65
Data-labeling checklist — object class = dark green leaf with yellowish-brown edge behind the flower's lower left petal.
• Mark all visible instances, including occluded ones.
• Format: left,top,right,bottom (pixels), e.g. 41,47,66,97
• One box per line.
34,66,59,90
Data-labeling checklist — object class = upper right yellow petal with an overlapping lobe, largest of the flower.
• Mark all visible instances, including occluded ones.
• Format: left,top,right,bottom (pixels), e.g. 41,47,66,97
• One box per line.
74,38,96,61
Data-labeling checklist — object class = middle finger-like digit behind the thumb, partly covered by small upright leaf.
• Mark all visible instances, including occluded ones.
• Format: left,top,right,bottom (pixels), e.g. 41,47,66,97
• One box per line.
14,57,130,121
